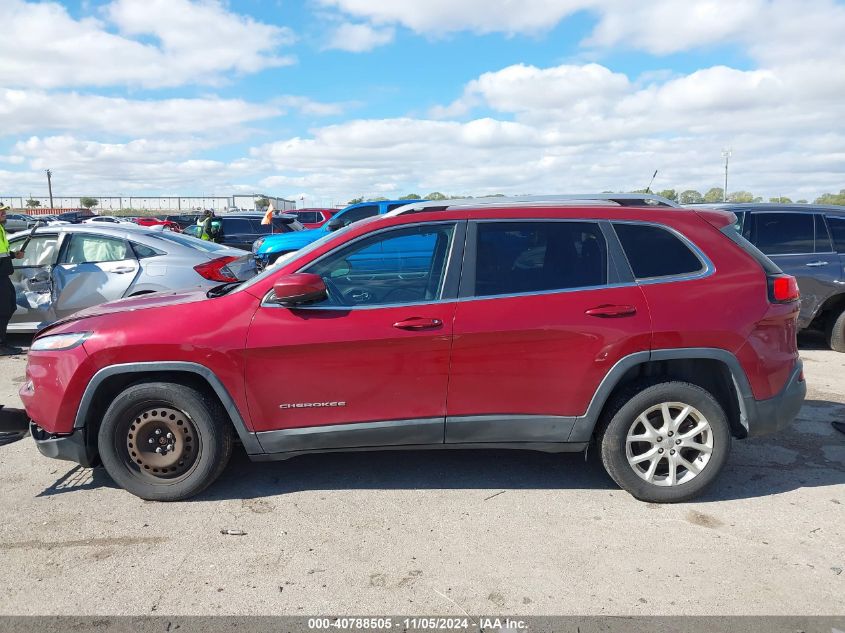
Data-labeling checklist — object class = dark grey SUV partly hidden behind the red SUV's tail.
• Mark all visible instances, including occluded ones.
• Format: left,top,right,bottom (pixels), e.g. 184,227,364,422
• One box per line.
707,204,845,352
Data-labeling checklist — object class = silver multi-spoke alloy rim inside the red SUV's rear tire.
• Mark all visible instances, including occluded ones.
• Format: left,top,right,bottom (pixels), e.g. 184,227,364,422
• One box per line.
625,402,713,486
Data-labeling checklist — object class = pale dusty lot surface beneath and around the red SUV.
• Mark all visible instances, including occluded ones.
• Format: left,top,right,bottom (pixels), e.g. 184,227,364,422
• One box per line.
0,340,845,615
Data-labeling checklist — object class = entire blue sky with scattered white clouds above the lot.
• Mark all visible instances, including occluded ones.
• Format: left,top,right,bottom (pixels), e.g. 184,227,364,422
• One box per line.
0,0,845,204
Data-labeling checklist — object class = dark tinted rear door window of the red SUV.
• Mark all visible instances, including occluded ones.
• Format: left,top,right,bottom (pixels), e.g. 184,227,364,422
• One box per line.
472,221,607,297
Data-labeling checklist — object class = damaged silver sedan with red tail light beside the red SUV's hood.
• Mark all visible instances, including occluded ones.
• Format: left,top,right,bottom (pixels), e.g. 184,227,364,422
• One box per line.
8,224,255,333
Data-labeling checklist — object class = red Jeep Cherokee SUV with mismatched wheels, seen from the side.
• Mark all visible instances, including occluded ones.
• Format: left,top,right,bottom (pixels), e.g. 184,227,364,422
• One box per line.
21,196,806,502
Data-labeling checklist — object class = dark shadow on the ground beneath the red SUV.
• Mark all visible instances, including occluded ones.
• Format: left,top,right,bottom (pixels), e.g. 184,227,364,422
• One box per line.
38,400,845,503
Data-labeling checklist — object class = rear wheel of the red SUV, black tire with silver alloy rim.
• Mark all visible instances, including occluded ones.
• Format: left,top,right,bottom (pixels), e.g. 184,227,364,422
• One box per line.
599,382,731,503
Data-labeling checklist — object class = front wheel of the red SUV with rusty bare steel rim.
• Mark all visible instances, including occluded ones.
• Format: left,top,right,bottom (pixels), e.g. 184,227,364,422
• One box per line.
97,382,232,501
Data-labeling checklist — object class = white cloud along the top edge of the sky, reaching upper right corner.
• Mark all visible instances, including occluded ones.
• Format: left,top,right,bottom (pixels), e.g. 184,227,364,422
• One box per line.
318,0,845,68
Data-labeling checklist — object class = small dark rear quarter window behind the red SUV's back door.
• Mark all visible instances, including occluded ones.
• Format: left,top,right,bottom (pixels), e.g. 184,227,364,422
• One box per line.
613,223,704,279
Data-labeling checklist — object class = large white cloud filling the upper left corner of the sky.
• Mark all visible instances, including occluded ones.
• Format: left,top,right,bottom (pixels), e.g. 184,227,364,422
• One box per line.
0,0,294,88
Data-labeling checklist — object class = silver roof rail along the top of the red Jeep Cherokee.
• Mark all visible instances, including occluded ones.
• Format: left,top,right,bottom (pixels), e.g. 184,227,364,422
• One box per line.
386,193,681,217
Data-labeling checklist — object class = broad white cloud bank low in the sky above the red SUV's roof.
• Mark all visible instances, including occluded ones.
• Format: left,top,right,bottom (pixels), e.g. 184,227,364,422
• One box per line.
247,49,845,198
